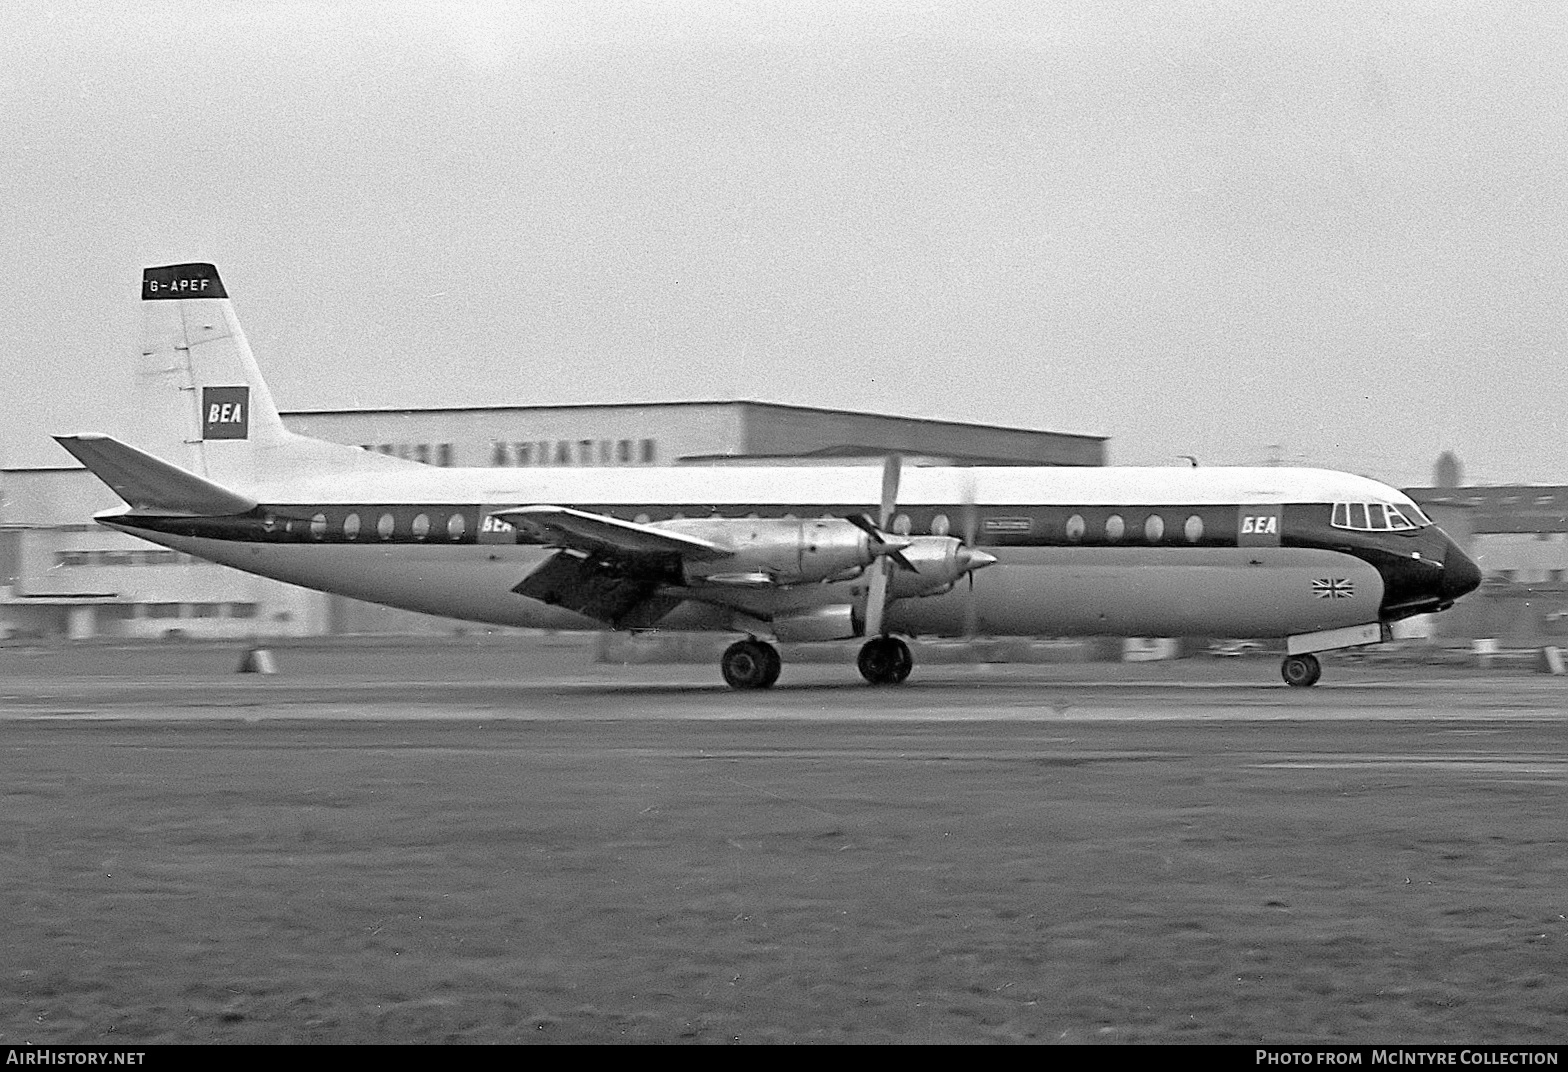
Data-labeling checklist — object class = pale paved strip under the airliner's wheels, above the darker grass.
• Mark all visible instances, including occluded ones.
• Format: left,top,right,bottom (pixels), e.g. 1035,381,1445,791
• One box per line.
0,660,1568,723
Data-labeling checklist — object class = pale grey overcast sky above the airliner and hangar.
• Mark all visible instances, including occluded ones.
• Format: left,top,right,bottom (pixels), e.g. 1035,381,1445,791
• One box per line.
0,0,1568,484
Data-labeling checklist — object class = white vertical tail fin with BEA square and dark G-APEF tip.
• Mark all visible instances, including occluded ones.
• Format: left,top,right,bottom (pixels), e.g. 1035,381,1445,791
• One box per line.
135,263,412,487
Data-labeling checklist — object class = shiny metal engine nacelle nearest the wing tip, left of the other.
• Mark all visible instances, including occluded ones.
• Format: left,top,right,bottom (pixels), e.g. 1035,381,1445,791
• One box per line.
660,517,884,585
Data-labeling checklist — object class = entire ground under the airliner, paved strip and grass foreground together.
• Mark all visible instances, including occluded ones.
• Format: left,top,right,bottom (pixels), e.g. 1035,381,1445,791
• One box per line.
0,652,1568,1044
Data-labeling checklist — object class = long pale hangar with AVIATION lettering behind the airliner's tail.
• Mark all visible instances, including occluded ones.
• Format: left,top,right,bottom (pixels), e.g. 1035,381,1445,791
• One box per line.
0,401,1105,639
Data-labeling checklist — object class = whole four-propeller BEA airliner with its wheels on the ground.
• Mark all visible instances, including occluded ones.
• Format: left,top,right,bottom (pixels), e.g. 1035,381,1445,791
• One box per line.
58,263,1480,688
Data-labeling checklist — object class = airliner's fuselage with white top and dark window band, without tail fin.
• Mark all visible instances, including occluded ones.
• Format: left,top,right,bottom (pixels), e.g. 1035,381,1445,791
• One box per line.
100,467,1479,636
